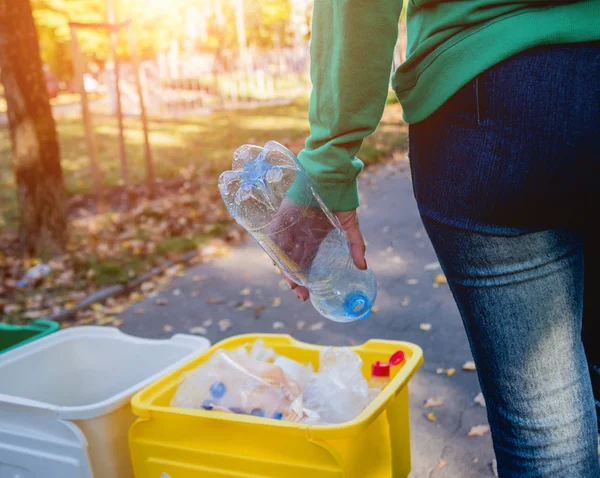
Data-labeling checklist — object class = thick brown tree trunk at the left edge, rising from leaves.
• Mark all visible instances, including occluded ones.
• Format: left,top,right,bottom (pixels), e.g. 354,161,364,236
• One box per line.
0,0,67,257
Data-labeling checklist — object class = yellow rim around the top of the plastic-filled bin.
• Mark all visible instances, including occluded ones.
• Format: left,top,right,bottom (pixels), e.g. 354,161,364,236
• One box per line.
131,334,423,441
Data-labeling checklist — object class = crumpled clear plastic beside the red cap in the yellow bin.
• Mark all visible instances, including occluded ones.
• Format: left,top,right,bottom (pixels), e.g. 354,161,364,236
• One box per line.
303,347,372,424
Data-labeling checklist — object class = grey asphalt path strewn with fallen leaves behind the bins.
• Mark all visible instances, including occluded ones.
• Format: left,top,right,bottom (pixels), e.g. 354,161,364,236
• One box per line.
122,162,493,478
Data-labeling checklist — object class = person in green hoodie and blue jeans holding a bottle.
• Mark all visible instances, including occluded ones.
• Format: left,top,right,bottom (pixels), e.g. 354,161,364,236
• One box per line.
293,0,600,478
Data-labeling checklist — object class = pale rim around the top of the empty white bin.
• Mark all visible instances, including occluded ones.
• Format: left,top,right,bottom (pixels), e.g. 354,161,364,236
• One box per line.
0,326,210,420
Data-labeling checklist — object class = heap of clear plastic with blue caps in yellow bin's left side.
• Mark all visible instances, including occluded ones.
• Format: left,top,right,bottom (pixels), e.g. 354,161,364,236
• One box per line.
171,341,302,420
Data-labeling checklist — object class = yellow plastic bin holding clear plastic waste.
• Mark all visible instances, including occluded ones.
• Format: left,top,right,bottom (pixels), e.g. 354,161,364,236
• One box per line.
129,335,423,478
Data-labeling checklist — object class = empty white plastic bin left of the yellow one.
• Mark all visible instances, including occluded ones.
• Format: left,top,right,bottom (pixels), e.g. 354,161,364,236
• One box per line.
0,327,210,478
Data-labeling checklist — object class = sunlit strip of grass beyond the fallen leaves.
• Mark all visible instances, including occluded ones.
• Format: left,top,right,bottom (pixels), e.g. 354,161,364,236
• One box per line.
0,94,407,227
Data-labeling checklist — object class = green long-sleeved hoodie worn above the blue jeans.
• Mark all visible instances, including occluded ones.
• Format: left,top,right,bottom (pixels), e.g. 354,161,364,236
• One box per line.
299,0,600,211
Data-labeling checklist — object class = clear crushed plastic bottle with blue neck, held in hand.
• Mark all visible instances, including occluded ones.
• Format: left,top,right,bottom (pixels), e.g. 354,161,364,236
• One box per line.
219,141,377,322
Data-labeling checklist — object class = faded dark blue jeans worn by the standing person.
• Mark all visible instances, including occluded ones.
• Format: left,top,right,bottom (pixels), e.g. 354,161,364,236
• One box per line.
410,40,600,478
